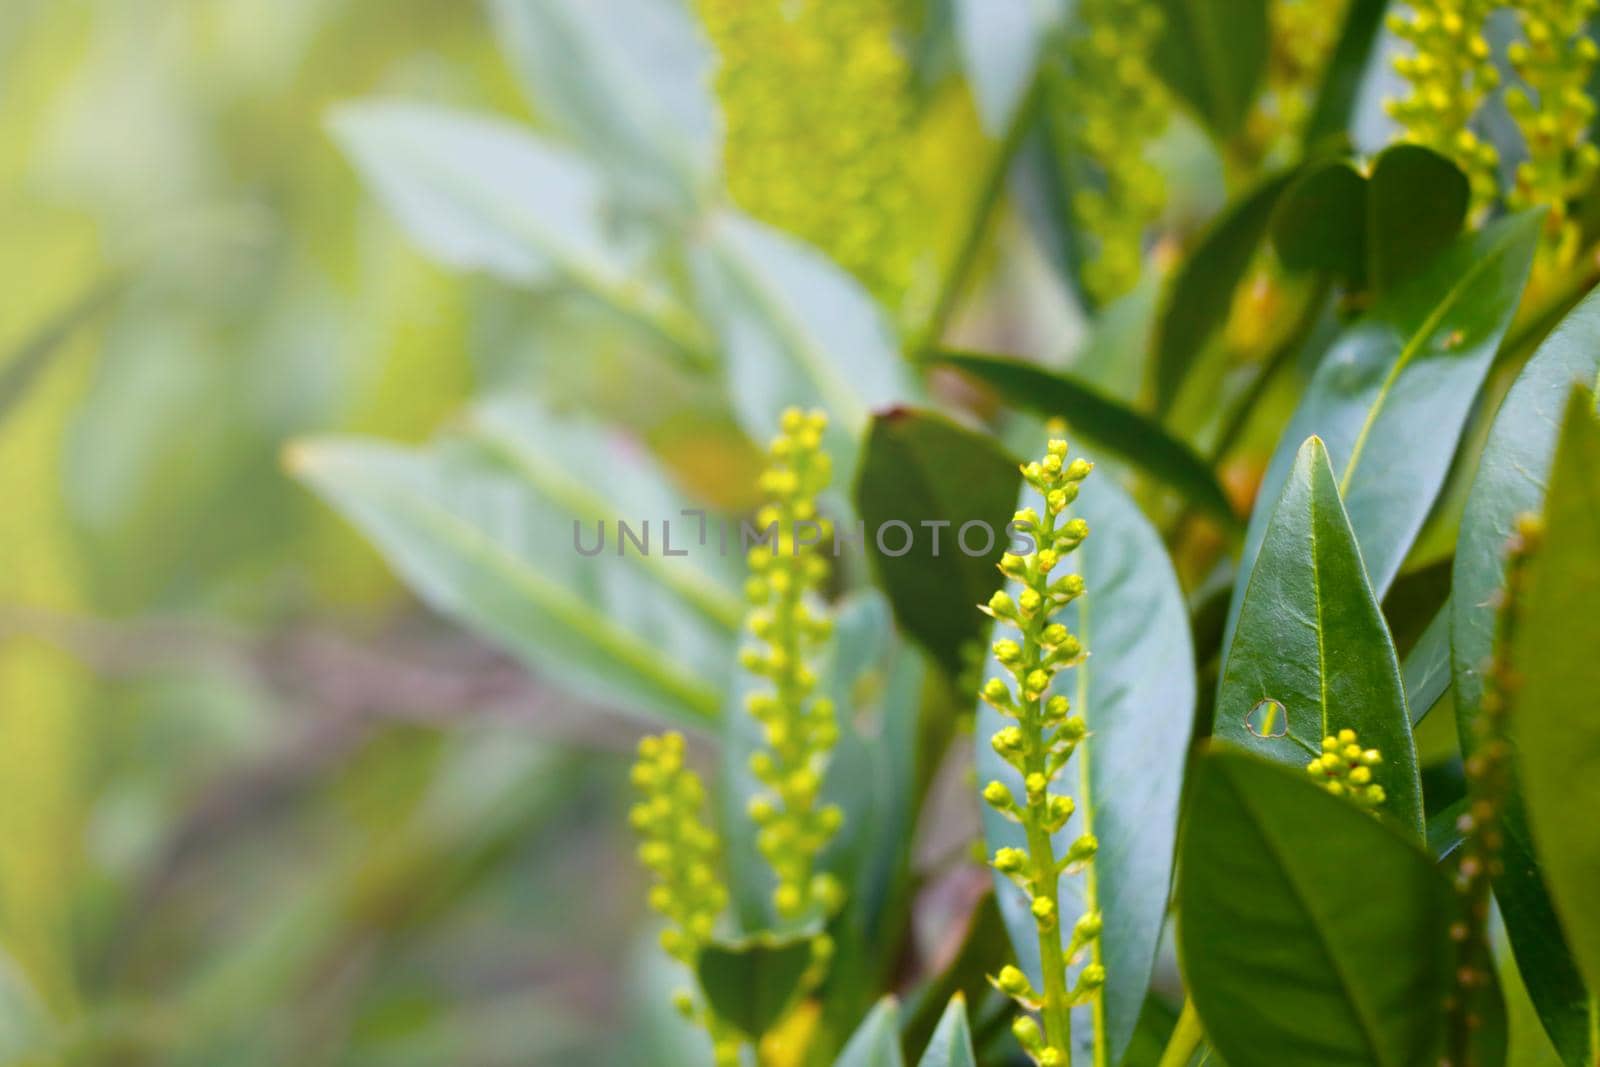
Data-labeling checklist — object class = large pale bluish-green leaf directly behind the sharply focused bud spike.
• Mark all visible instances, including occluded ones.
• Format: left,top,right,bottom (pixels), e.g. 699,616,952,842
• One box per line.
978,474,1195,1062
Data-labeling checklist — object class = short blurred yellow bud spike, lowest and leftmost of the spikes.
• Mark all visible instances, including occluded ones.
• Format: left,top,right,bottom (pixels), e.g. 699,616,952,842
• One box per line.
629,733,741,1067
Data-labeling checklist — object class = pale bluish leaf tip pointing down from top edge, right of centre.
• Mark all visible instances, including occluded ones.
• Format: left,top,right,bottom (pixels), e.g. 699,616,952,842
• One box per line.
954,0,1058,138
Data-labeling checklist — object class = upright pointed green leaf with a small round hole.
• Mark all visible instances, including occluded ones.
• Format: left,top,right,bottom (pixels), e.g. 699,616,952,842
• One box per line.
1213,437,1422,840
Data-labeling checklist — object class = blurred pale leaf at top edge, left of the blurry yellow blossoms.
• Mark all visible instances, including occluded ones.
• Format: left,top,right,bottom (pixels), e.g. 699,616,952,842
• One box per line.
491,0,717,208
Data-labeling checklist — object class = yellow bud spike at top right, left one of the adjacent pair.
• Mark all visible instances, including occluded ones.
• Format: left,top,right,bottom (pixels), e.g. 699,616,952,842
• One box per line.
1386,0,1499,211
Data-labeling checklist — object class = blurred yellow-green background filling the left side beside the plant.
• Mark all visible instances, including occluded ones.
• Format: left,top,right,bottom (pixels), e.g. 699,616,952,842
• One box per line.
0,0,681,1065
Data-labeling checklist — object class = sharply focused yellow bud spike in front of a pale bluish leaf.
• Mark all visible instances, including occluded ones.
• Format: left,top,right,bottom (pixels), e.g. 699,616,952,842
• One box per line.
981,440,1106,1064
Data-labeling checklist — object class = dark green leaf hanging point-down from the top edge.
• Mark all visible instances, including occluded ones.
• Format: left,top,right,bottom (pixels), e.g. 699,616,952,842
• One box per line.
1152,0,1269,141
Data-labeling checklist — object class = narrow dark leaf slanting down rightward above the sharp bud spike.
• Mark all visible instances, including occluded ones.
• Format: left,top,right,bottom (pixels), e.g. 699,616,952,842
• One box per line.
936,352,1238,525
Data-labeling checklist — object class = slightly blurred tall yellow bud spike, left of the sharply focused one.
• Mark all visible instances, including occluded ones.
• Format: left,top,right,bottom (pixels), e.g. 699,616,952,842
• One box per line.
741,410,843,920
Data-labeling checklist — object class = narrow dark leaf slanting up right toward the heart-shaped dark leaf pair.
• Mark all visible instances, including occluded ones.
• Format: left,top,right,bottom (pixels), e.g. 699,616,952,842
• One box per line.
1155,173,1293,411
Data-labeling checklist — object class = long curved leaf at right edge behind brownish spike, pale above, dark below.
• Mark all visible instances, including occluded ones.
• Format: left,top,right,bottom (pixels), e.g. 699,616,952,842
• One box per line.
1451,294,1600,1065
